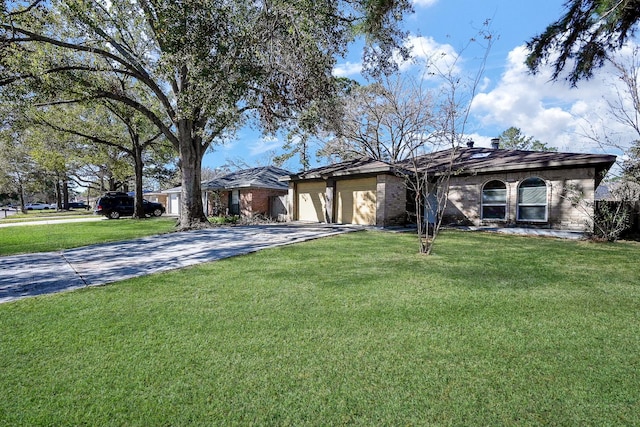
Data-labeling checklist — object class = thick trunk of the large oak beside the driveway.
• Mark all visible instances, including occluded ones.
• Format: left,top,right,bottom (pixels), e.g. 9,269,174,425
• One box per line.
178,120,210,230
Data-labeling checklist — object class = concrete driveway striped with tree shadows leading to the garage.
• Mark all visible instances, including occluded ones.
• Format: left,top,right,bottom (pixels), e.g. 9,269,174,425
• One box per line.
0,224,356,303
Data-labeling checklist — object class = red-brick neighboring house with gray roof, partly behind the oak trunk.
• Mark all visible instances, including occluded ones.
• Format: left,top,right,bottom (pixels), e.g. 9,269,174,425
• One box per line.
163,166,291,220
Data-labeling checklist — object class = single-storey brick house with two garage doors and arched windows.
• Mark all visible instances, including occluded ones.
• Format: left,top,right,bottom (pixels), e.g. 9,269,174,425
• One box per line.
285,147,615,234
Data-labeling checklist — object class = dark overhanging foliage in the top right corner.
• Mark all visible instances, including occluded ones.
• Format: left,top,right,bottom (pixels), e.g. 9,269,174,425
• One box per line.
527,0,640,84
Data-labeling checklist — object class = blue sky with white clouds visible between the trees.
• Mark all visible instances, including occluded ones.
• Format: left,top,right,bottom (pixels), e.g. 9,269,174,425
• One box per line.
203,0,632,171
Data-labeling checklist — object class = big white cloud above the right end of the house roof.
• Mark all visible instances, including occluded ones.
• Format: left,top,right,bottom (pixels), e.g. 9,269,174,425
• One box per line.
471,46,628,152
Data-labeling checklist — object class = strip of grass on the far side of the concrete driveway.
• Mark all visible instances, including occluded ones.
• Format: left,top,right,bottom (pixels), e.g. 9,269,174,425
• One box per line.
0,217,176,256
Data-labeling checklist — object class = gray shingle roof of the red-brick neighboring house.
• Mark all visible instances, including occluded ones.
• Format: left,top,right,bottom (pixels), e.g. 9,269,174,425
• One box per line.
163,166,291,193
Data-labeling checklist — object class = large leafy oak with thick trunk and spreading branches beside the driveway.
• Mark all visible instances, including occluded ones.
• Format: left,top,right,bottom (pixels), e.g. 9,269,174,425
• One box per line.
0,0,411,229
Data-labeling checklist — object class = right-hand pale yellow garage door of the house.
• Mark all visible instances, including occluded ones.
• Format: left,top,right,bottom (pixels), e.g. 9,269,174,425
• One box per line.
336,178,376,225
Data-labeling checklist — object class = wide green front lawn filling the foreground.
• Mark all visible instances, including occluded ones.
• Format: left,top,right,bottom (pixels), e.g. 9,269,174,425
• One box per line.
0,232,640,426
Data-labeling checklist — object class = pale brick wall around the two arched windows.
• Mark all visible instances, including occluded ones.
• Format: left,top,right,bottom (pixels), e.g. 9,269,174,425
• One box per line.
443,168,595,231
